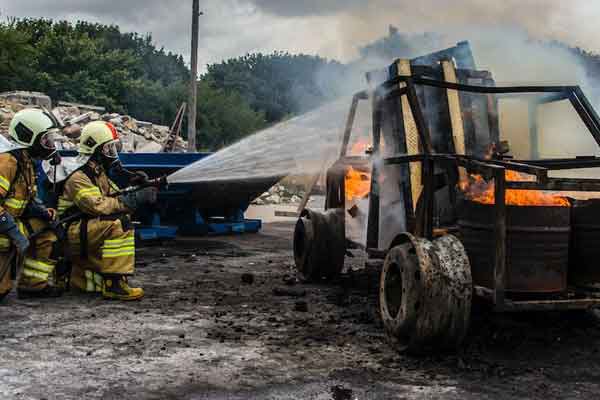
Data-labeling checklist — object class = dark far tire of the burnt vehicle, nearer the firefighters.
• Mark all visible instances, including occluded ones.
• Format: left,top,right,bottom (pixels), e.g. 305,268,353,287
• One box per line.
294,209,346,282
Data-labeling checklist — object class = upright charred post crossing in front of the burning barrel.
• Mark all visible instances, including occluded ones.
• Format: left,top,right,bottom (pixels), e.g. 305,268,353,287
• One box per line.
494,168,506,309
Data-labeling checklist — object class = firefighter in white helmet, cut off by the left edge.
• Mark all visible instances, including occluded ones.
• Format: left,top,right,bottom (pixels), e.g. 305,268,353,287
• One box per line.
0,109,63,299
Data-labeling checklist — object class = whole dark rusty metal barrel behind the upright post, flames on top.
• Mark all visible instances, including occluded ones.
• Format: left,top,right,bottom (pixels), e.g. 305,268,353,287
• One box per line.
459,201,571,293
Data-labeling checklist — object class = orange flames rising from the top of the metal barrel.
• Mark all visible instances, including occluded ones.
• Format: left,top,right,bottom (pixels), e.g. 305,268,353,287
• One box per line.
460,170,570,207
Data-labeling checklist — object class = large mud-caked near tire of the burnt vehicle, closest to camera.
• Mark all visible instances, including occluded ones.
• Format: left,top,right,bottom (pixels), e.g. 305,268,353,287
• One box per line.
379,234,472,353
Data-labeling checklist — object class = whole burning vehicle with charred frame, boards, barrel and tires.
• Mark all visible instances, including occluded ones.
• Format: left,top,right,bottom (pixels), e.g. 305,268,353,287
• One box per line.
294,42,600,351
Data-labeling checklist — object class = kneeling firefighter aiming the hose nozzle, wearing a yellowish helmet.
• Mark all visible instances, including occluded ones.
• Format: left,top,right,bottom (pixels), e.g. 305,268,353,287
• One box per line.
58,121,153,300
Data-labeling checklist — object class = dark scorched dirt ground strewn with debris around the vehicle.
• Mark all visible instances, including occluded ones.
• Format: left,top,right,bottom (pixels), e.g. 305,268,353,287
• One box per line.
0,222,600,400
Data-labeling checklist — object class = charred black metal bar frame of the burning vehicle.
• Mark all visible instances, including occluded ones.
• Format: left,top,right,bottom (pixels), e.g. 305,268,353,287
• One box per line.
366,76,600,311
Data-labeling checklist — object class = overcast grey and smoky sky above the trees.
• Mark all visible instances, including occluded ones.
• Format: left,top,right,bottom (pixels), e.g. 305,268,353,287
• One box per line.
0,0,600,74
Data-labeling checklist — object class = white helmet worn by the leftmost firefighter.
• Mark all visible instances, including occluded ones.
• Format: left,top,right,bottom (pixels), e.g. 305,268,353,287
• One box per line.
8,108,57,147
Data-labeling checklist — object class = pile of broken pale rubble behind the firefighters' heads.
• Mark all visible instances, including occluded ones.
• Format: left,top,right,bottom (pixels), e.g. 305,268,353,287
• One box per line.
0,92,187,153
